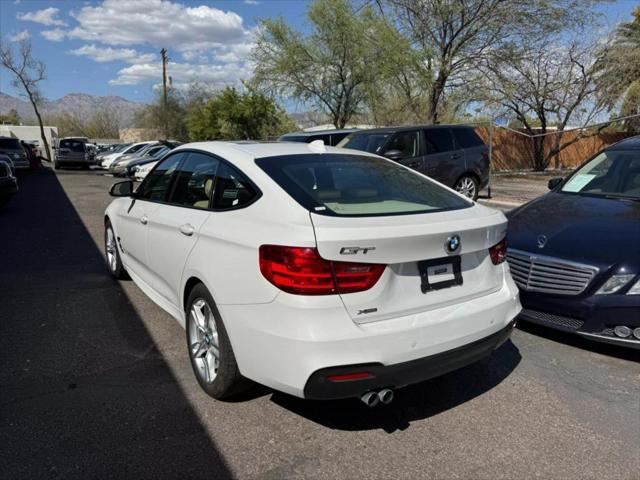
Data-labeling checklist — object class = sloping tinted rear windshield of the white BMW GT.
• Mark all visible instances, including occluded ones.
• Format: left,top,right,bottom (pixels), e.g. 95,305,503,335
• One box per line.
256,153,472,216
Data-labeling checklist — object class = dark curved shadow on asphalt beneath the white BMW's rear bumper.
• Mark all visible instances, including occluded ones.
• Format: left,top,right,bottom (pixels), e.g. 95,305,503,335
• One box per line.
271,340,521,433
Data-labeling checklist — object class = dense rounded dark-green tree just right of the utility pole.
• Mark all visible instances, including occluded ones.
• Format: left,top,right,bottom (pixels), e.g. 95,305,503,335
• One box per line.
186,87,295,140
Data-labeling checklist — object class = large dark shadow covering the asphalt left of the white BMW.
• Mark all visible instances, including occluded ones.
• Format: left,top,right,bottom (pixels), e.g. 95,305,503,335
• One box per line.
0,168,232,479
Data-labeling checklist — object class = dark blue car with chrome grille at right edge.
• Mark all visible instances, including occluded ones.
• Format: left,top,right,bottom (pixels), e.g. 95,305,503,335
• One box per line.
508,137,640,348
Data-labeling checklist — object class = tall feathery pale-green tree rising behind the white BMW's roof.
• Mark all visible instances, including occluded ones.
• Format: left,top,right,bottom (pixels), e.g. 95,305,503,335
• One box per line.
252,0,397,128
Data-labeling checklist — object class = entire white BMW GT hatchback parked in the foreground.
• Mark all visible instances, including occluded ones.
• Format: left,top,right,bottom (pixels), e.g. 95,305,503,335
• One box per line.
104,142,521,405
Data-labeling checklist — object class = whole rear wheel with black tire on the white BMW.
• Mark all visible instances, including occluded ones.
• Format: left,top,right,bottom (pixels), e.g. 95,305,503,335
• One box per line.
185,283,247,400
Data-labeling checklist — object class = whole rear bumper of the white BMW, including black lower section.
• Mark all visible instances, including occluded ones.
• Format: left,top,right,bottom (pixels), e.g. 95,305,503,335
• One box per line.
218,276,521,398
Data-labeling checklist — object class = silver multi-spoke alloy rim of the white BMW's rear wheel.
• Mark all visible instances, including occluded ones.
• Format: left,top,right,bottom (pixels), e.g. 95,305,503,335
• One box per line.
189,298,220,383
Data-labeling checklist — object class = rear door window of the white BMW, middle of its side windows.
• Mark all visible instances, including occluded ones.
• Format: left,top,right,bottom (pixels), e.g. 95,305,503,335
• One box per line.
169,153,220,209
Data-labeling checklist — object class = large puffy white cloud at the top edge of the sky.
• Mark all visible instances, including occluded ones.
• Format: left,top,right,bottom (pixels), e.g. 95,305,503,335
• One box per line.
69,0,249,51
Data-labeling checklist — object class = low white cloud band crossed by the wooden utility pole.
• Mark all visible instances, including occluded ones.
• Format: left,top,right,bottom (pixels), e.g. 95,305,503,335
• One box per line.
109,63,251,88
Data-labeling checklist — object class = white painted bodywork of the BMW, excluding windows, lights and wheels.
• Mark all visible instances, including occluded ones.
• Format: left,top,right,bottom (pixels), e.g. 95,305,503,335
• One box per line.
106,142,521,397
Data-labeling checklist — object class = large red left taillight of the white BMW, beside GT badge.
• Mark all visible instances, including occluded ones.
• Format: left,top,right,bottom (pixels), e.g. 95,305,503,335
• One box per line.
260,245,385,295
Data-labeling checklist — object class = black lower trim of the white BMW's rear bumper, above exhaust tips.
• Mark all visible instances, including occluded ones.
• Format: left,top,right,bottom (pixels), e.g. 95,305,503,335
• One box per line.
304,320,515,400
